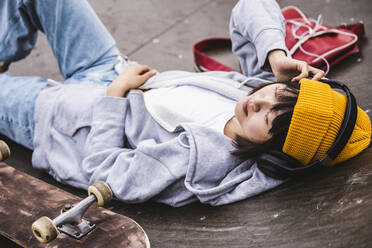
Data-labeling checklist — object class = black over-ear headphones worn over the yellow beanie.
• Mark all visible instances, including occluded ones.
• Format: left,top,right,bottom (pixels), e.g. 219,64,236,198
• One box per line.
257,79,358,180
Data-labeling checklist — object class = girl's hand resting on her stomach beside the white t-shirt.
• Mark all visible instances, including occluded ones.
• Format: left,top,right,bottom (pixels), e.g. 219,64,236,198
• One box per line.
106,65,156,97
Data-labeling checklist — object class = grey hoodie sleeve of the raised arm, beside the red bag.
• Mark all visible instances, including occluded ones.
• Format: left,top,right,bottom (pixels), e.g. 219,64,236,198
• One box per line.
230,0,288,76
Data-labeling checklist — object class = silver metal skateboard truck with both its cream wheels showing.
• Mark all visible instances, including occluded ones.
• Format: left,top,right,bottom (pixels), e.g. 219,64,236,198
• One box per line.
32,182,112,243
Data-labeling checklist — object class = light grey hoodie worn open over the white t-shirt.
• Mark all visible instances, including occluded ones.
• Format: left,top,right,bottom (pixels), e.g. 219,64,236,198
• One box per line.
33,0,286,206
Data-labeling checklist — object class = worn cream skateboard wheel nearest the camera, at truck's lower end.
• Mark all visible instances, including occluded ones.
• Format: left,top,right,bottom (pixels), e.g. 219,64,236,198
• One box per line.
32,216,59,244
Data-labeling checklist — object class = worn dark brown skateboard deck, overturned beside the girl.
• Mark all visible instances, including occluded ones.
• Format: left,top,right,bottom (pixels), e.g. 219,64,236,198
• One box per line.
0,162,150,248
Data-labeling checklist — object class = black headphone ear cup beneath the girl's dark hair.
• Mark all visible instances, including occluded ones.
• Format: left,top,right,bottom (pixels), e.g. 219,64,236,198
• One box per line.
257,150,300,180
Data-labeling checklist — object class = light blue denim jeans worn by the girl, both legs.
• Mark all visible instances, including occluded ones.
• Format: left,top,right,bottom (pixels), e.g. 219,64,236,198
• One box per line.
0,0,120,149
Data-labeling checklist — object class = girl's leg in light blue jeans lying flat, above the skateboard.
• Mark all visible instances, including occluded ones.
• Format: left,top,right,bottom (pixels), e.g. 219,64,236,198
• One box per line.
0,73,47,149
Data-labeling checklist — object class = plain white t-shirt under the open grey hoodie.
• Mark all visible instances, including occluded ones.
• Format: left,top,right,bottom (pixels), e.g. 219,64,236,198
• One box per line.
144,85,236,134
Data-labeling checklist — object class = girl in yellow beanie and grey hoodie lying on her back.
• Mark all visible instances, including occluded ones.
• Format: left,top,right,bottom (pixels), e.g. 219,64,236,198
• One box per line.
0,0,371,206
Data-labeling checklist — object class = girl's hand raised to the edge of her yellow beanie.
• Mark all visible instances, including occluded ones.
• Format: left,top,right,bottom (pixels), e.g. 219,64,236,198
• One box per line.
268,50,324,82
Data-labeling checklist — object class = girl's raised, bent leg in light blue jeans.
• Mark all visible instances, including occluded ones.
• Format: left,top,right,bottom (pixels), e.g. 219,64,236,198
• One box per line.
0,0,119,79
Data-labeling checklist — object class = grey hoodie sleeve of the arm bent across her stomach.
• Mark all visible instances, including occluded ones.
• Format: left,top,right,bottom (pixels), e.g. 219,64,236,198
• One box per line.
82,97,187,203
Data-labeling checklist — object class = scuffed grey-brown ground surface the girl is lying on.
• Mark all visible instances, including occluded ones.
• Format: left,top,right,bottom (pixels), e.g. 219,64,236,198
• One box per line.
0,0,372,248
